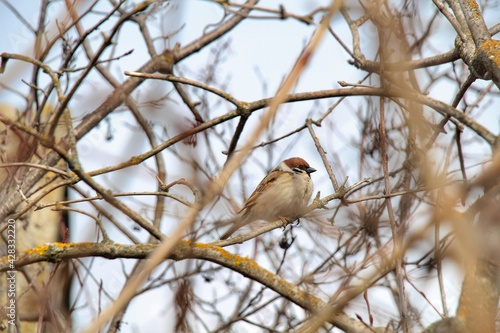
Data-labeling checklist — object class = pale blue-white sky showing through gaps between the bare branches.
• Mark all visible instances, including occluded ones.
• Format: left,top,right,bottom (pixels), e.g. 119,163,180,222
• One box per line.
0,0,499,333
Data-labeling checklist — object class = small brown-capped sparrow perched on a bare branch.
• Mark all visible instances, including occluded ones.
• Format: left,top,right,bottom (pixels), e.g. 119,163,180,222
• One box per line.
220,157,316,239
